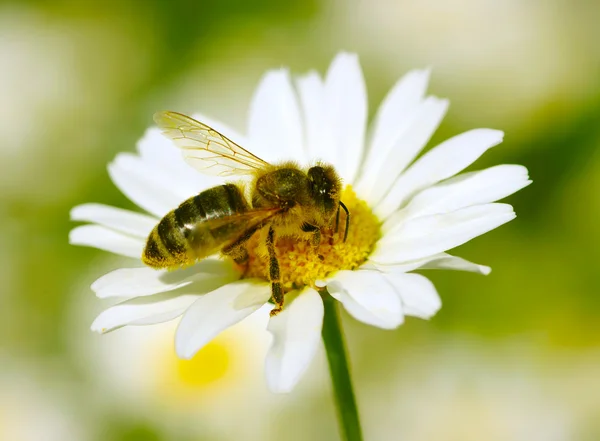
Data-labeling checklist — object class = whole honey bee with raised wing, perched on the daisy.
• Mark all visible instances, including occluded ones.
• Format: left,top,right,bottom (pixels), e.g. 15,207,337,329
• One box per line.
142,111,350,315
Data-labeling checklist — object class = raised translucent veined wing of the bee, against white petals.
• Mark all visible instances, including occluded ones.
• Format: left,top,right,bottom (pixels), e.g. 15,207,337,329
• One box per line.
154,111,269,176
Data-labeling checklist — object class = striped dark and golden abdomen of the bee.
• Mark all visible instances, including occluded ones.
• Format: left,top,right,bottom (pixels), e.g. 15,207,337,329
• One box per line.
142,184,249,268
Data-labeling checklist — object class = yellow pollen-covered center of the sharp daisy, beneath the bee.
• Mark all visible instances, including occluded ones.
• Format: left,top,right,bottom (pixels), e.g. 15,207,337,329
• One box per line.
244,186,381,292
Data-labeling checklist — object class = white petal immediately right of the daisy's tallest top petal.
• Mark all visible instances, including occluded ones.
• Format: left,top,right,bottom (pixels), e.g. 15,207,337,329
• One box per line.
366,69,429,162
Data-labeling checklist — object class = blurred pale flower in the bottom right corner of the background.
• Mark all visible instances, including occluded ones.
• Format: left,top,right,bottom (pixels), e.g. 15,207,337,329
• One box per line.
362,344,600,441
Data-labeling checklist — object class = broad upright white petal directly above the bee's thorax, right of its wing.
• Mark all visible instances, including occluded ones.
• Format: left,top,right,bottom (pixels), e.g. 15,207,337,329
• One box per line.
248,69,306,163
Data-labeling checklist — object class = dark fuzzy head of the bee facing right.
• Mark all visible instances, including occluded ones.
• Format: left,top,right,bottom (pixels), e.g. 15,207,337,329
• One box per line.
308,165,342,219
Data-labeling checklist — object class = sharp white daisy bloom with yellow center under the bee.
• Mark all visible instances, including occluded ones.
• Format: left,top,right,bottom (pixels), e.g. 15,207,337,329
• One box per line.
70,53,531,392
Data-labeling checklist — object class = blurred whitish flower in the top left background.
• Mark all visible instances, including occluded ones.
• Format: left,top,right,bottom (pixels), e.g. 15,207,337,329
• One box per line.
0,2,153,204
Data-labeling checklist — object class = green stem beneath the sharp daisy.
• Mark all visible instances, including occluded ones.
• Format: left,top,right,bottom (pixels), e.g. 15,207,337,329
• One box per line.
323,293,362,441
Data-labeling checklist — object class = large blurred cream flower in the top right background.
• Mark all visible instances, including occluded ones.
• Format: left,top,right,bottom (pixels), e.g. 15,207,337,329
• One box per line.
324,0,598,130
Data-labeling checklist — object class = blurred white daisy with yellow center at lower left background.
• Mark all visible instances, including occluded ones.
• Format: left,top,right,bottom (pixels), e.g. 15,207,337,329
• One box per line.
74,308,276,440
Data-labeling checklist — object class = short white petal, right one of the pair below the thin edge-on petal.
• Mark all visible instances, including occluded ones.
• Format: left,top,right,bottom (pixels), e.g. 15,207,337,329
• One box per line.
385,273,442,319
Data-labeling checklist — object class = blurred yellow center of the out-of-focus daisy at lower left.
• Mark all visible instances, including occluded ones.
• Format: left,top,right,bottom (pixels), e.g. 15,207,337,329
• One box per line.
176,340,230,387
